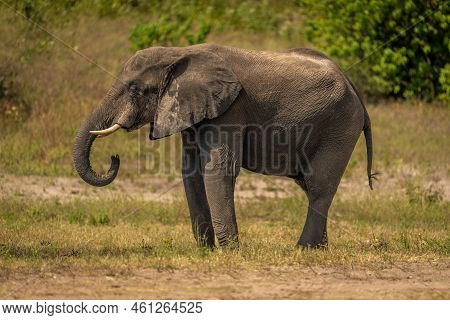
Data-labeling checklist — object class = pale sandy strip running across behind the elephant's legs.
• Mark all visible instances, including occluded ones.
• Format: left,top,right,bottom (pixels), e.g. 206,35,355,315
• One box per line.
0,174,450,202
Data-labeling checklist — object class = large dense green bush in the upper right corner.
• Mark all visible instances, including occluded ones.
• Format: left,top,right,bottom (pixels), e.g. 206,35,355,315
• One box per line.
299,0,450,102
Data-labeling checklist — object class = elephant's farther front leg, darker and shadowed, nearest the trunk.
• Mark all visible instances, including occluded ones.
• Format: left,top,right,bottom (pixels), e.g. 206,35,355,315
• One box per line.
182,133,215,247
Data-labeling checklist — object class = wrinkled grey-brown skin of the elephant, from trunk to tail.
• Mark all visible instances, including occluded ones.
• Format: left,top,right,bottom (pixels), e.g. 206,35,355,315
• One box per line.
73,45,372,248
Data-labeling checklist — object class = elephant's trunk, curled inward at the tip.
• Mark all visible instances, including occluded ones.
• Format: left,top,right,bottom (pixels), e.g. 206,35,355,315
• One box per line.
73,107,120,187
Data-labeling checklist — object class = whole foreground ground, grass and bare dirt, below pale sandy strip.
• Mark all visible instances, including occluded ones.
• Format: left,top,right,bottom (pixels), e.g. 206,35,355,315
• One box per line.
0,184,450,299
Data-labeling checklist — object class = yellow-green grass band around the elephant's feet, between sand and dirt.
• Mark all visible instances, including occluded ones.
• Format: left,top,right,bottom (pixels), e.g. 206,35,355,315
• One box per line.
0,188,450,273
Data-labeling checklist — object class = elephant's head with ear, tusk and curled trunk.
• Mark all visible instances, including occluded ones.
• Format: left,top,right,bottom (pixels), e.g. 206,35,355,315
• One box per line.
73,46,241,186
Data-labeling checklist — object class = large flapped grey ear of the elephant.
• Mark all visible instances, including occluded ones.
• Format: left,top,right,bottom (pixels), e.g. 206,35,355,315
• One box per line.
150,51,241,140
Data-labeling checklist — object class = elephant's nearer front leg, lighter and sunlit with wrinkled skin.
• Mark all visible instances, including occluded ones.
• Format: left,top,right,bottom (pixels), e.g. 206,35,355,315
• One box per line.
204,145,238,246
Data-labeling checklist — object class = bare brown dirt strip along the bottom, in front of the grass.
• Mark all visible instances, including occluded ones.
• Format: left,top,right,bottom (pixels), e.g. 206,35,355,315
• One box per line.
0,263,450,299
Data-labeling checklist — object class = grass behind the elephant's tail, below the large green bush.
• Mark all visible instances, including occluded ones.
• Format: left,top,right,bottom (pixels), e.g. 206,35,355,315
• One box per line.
346,102,450,178
